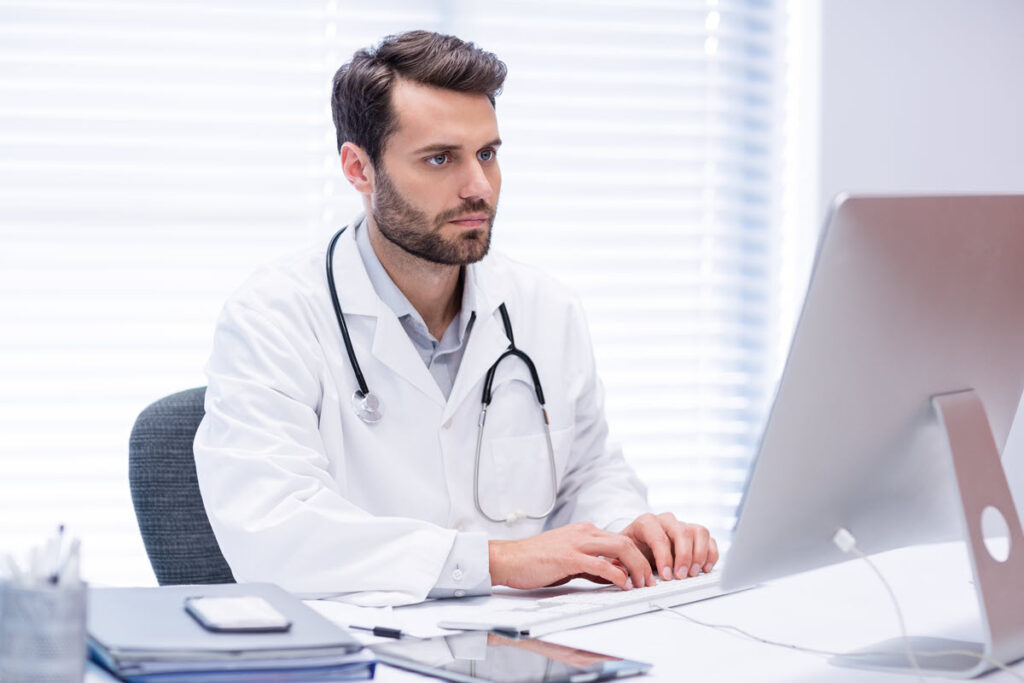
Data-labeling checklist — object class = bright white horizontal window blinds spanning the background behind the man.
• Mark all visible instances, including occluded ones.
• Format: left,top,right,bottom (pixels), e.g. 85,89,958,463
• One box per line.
0,0,783,584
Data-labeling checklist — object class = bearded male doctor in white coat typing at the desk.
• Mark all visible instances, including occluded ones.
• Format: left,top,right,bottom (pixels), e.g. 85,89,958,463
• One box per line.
195,31,718,604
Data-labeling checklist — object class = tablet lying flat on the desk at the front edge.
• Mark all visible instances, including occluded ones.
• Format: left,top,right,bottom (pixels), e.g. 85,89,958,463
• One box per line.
371,632,650,683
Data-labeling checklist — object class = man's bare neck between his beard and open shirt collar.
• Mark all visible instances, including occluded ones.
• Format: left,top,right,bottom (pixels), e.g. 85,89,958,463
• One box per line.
367,216,463,339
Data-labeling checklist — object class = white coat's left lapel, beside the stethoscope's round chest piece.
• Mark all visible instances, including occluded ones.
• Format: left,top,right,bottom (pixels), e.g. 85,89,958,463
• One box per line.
334,222,444,405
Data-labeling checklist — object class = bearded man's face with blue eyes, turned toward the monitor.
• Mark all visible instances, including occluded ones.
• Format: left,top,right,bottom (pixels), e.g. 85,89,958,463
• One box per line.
371,80,502,265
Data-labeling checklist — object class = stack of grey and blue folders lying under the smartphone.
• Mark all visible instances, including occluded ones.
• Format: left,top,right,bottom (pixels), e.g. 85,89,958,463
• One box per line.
88,584,375,683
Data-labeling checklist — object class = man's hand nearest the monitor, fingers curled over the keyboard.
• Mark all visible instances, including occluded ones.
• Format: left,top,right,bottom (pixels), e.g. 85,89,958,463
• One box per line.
623,512,718,580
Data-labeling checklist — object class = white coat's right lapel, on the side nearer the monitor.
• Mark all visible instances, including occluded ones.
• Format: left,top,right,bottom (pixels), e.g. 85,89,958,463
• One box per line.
443,260,509,420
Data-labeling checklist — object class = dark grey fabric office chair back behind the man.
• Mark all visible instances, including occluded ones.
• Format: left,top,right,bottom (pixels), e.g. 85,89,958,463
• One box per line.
128,387,234,586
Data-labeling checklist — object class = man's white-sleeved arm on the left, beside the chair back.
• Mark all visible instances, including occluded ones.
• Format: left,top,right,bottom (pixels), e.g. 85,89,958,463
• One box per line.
195,302,486,604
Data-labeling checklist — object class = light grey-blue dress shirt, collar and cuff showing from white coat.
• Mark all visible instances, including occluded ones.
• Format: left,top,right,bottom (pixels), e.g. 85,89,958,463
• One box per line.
355,217,490,598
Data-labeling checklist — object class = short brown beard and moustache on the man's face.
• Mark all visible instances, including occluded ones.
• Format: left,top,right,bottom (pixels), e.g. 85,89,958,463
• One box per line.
372,165,495,265
